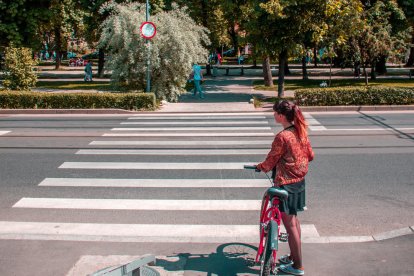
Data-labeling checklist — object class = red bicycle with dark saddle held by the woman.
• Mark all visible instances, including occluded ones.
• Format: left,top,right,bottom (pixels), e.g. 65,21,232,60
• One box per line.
244,165,288,276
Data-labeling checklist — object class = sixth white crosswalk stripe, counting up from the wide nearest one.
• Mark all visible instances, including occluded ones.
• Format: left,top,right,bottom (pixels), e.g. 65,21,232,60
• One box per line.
89,140,272,147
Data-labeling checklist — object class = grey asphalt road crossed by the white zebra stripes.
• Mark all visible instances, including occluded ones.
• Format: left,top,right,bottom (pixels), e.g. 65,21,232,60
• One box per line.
0,111,414,275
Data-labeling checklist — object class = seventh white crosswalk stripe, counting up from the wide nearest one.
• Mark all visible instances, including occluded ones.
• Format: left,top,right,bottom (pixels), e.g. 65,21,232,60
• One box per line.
102,132,274,137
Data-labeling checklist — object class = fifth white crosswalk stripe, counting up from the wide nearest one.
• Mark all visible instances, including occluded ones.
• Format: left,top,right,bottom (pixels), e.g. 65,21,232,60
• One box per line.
76,149,269,156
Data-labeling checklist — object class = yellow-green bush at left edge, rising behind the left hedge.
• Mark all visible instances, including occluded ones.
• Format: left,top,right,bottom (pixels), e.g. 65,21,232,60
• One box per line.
3,47,37,90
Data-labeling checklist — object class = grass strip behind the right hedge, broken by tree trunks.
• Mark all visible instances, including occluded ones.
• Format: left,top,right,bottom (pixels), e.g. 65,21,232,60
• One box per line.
253,78,414,91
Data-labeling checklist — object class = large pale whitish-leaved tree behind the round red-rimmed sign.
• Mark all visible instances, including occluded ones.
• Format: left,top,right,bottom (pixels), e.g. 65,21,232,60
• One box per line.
99,3,210,101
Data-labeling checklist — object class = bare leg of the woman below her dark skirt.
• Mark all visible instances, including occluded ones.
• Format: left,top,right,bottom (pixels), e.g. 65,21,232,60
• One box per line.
282,213,303,269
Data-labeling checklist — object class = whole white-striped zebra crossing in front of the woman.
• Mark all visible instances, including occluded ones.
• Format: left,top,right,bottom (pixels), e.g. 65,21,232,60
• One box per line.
0,113,319,243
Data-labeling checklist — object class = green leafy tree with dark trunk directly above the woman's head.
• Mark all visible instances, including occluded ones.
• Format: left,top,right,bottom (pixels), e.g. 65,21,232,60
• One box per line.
246,0,325,97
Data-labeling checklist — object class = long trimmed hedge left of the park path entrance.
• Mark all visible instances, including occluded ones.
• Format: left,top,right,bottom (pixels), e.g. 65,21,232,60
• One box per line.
0,91,156,110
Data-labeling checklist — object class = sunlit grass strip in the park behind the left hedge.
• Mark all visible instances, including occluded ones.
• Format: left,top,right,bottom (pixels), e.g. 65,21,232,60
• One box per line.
36,81,113,91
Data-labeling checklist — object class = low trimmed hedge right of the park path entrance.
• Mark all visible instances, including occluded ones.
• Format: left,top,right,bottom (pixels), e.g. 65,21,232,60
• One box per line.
295,86,414,106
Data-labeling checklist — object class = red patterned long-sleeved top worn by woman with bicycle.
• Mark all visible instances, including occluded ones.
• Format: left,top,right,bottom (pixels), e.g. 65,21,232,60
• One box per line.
257,127,314,186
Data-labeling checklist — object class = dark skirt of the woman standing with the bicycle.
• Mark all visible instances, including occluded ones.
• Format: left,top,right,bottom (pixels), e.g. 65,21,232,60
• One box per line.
279,179,306,215
